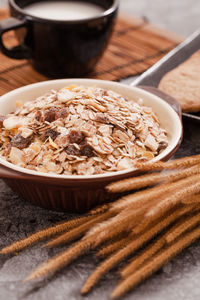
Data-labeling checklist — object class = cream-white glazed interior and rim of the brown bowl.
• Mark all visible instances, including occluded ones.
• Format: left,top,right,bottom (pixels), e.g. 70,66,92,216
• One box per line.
0,79,182,179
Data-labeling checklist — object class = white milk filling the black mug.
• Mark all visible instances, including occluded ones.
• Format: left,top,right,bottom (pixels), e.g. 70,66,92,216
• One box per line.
24,1,103,21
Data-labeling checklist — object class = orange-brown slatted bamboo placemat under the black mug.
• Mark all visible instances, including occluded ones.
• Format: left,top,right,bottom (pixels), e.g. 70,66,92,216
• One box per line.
0,9,182,95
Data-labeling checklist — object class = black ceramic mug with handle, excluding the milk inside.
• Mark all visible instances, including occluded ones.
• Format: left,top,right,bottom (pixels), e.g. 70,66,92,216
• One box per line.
0,0,118,78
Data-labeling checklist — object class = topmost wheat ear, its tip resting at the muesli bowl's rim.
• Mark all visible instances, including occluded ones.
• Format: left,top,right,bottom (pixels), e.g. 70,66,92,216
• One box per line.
134,154,200,171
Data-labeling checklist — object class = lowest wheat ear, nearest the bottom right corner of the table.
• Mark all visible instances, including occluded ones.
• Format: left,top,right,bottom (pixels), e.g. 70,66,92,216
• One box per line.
111,227,200,299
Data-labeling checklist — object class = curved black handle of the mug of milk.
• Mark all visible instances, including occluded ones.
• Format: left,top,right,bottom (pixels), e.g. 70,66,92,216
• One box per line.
0,18,31,59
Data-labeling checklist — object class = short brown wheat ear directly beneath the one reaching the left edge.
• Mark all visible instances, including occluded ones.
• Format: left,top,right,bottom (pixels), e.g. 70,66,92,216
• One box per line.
44,211,114,247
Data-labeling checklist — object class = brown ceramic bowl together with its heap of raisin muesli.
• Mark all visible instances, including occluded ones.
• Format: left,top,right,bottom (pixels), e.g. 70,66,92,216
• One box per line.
0,79,182,212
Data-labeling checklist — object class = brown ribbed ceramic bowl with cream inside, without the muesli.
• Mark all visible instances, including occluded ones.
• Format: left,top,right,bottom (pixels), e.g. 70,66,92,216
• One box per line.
0,79,182,212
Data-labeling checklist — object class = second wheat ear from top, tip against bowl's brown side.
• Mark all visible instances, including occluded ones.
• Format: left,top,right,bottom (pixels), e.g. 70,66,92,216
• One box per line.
106,165,200,193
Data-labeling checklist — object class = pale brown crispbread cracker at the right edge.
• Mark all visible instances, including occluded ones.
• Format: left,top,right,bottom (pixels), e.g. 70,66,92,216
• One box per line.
158,50,200,112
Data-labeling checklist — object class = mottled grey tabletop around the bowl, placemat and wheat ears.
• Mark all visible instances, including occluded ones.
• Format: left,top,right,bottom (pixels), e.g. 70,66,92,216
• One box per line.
0,0,200,300
